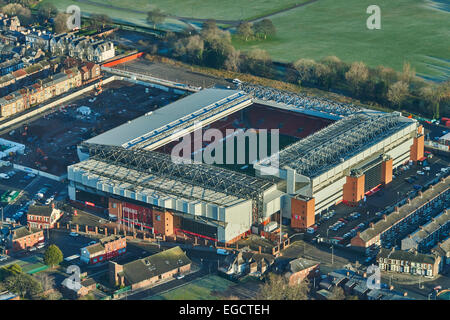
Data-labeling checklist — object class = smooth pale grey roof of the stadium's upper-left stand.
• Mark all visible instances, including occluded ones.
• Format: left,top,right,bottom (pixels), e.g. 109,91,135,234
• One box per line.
86,89,244,147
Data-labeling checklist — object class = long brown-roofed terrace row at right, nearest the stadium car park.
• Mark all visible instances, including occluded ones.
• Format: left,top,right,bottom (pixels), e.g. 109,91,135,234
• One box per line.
351,176,450,252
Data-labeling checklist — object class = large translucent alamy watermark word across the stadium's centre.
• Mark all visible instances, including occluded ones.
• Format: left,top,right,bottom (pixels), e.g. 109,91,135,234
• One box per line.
171,123,280,174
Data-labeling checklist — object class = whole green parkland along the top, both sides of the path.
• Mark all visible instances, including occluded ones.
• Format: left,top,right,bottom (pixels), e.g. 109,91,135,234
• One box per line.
40,0,450,80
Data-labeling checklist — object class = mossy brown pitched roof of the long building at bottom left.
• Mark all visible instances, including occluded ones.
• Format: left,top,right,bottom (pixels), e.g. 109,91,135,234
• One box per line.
123,247,191,284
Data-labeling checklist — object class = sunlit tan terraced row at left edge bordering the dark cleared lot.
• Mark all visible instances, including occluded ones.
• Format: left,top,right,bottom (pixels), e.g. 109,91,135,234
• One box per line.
0,63,101,118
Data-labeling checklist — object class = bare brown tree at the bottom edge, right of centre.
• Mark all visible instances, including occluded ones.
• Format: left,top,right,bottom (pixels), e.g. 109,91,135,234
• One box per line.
257,274,309,300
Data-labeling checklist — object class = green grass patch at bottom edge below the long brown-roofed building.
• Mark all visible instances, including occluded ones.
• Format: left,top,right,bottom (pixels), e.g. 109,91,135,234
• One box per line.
148,275,235,300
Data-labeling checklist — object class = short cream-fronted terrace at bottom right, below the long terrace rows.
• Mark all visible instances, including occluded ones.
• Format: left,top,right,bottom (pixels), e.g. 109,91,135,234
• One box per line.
377,248,441,277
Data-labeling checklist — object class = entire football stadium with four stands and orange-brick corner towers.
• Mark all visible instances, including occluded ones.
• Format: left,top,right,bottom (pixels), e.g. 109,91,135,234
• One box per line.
68,84,424,243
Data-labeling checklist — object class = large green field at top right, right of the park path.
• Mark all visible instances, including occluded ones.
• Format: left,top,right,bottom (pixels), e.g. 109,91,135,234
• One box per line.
234,0,450,79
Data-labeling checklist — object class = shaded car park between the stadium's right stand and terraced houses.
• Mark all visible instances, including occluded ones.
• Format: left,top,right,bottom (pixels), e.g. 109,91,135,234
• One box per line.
312,156,450,245
